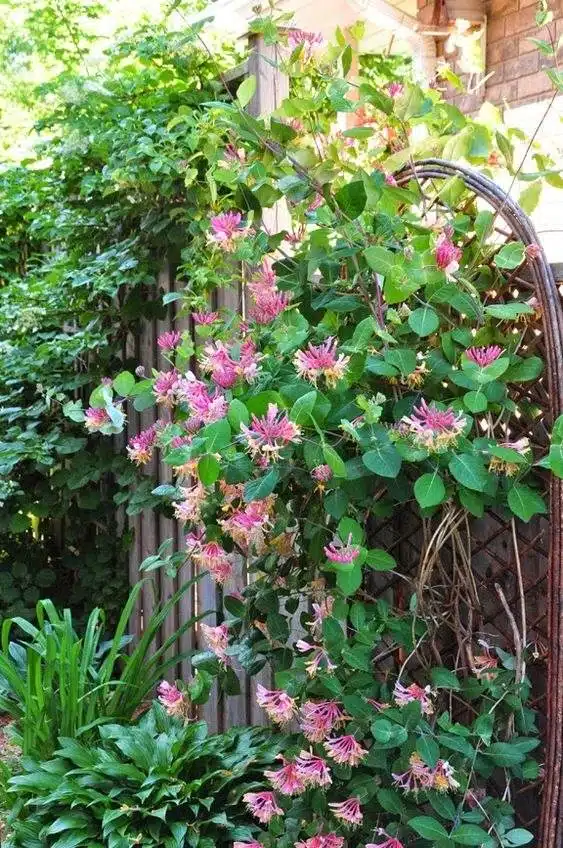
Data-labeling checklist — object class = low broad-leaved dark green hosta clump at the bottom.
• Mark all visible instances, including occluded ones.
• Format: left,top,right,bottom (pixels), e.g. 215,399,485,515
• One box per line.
6,703,283,848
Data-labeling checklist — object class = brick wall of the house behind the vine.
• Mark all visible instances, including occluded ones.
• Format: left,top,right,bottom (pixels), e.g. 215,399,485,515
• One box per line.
485,0,563,105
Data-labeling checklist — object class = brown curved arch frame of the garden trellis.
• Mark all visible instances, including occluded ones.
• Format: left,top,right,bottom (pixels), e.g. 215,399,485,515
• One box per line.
395,159,563,848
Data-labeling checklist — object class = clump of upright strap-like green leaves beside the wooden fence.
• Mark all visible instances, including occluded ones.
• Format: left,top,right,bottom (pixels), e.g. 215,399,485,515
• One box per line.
0,578,205,758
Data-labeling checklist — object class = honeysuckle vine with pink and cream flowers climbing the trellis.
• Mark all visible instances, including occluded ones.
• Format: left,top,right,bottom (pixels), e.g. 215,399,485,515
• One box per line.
80,11,563,848
